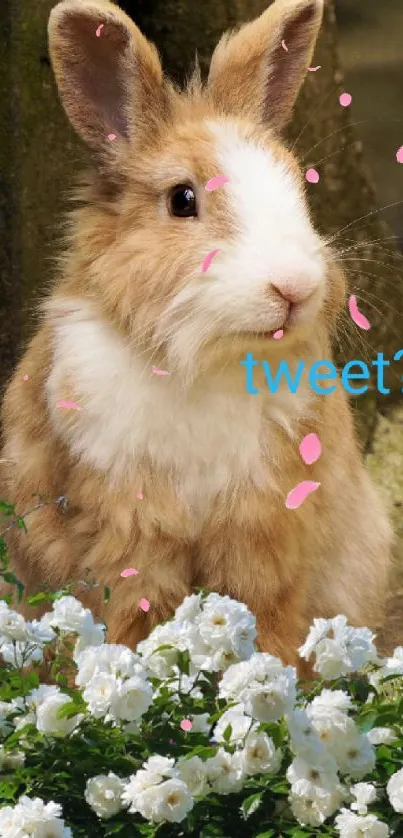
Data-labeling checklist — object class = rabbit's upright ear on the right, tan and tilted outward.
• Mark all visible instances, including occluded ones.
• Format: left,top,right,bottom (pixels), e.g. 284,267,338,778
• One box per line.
208,0,323,130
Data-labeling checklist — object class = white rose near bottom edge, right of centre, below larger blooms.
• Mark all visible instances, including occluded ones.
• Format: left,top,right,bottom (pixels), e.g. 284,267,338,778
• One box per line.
288,780,342,826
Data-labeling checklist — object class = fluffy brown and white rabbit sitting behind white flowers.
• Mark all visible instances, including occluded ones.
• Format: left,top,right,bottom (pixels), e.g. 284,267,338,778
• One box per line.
1,0,390,662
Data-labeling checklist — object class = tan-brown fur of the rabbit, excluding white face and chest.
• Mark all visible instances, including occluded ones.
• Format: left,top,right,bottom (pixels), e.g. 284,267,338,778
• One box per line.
0,0,390,662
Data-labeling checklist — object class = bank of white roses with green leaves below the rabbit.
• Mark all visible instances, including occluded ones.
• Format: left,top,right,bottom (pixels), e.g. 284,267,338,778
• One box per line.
0,593,403,838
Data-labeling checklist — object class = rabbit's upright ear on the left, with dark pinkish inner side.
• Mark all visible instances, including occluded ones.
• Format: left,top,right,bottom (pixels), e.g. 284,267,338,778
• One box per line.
48,0,164,151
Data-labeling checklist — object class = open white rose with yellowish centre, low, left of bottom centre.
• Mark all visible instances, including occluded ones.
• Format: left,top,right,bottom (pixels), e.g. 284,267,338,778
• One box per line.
130,777,194,823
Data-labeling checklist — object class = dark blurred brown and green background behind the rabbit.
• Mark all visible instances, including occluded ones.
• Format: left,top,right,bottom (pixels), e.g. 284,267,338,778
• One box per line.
0,0,403,640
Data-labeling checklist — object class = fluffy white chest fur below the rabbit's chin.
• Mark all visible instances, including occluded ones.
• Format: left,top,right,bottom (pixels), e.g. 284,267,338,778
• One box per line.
47,302,274,515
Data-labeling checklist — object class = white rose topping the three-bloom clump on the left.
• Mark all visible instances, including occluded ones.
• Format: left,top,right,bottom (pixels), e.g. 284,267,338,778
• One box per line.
76,643,144,687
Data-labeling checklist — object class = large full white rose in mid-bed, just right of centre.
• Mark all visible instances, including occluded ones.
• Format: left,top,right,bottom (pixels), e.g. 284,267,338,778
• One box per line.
219,652,296,722
